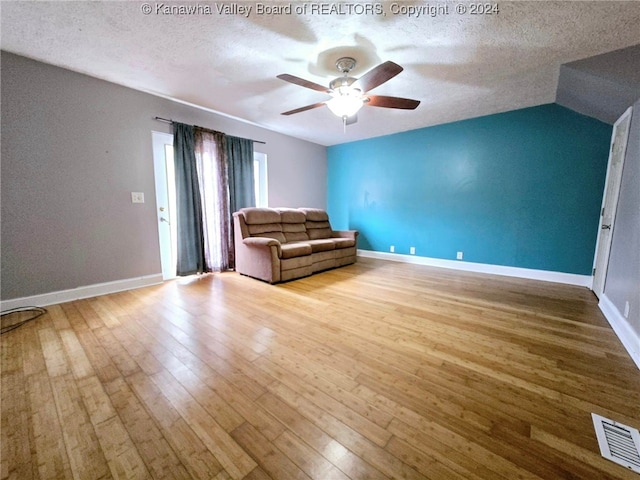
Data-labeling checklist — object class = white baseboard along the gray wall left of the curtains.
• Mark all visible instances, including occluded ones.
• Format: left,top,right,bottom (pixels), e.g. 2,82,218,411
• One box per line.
0,273,162,312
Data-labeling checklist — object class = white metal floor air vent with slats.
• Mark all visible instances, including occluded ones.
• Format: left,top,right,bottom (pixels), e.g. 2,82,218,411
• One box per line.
591,413,640,473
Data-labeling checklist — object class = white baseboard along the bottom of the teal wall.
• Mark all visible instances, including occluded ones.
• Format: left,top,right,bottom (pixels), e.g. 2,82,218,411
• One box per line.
358,250,593,288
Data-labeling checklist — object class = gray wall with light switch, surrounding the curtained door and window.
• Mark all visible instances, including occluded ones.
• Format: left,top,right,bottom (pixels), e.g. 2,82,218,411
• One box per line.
0,52,327,300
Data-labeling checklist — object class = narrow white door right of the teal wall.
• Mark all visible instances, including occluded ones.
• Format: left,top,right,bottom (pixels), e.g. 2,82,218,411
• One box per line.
592,107,632,298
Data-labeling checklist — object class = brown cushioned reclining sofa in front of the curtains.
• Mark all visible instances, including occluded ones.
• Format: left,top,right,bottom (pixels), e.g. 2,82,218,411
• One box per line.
233,208,358,283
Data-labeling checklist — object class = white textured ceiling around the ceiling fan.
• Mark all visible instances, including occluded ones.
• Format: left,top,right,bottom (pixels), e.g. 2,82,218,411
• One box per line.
0,0,640,145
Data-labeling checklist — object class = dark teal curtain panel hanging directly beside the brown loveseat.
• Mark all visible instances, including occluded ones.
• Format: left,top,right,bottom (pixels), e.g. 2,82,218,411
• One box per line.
225,135,256,268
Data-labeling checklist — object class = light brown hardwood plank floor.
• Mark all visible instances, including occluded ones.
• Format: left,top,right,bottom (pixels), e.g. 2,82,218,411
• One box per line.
1,259,640,480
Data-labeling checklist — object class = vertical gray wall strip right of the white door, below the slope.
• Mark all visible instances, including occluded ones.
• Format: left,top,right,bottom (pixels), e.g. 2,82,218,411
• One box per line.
604,100,640,337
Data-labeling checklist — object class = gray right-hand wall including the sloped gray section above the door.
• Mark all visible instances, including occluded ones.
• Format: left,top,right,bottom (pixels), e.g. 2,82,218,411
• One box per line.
556,45,640,337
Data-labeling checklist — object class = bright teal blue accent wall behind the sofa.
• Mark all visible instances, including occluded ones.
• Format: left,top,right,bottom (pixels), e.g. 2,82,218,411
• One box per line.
327,104,612,275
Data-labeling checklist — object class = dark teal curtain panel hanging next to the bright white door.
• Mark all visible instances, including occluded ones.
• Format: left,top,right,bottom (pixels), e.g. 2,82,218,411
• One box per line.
173,122,206,275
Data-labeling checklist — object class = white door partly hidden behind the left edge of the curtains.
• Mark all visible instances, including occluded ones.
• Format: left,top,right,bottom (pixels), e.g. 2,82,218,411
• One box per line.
152,132,177,280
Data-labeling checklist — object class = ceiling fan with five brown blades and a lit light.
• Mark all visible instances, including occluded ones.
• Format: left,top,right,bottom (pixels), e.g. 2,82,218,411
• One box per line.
277,57,420,127
